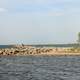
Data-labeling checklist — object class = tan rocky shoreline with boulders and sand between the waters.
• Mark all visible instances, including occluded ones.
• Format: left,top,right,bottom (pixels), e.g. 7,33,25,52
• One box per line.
0,45,80,56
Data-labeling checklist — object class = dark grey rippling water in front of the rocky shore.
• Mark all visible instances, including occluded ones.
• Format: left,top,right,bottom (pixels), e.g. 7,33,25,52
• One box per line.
0,56,80,80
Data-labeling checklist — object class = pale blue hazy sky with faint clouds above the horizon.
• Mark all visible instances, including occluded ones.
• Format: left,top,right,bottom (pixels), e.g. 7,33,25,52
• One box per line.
0,0,80,44
